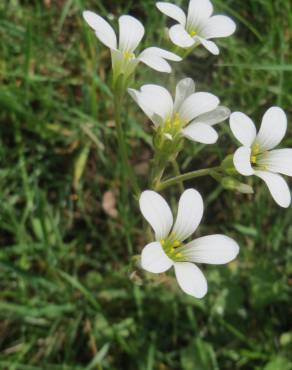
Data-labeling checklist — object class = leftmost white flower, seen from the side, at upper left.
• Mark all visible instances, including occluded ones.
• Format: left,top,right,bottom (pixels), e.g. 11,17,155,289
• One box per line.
83,10,181,76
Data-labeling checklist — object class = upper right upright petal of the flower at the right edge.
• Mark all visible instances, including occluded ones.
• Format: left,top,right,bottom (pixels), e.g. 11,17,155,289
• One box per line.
256,107,287,151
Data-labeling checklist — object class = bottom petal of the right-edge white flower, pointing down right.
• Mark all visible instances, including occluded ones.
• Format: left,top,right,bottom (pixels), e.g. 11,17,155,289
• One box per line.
255,171,291,208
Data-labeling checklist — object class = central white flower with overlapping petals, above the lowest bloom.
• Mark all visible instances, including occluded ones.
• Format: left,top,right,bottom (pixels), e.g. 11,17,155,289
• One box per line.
128,78,230,144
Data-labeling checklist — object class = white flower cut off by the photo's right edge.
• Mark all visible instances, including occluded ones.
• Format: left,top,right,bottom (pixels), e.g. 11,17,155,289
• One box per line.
230,107,292,208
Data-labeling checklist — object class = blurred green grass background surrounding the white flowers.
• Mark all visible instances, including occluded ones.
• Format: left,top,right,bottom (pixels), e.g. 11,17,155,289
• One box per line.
0,0,292,370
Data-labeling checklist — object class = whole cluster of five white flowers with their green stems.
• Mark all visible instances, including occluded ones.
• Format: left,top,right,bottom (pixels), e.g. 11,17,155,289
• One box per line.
83,0,292,298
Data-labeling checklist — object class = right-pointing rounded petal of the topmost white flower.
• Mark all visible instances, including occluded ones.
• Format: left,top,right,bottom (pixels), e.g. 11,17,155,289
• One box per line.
201,15,236,39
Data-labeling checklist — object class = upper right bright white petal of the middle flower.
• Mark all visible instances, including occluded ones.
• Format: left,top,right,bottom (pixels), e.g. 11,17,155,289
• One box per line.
178,92,219,123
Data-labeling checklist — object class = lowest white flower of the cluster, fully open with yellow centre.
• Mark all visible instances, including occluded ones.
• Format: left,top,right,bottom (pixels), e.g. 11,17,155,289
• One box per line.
140,189,239,298
